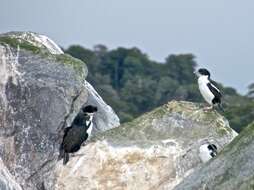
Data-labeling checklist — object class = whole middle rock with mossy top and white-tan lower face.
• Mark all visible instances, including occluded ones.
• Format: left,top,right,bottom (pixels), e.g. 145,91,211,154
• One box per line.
55,102,237,190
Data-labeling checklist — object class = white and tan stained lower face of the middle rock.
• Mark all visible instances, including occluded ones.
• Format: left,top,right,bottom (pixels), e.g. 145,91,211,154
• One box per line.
56,141,180,190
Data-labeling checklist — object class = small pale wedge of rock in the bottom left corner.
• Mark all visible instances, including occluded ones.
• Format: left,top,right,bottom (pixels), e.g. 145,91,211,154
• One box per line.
0,159,22,190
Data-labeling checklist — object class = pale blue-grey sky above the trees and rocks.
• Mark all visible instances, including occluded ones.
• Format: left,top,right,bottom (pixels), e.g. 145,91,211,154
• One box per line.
0,0,254,93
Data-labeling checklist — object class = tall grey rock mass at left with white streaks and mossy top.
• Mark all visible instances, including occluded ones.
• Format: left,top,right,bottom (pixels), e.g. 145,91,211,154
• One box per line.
0,32,119,190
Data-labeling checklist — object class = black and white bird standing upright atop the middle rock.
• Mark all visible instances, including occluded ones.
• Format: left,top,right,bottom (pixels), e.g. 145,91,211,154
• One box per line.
195,68,223,111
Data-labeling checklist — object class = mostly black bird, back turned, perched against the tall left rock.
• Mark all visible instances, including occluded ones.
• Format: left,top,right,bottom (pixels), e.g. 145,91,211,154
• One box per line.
59,105,97,165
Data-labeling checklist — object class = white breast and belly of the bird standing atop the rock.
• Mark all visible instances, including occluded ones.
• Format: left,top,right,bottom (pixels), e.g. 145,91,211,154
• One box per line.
198,76,214,105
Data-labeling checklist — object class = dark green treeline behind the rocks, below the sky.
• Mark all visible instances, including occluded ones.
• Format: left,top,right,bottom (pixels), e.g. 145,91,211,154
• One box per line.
65,45,254,132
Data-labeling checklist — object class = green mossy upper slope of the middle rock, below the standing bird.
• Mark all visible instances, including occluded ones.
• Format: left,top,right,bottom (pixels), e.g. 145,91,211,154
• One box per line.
91,101,233,145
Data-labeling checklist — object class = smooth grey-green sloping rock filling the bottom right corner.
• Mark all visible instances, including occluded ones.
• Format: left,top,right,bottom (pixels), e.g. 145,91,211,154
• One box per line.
175,123,254,190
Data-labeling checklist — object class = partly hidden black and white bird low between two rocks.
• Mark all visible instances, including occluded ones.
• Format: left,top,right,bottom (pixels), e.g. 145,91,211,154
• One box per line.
199,143,218,162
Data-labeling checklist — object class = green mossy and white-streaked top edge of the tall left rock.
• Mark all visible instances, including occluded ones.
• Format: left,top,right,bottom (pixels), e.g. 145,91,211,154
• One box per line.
0,32,87,80
